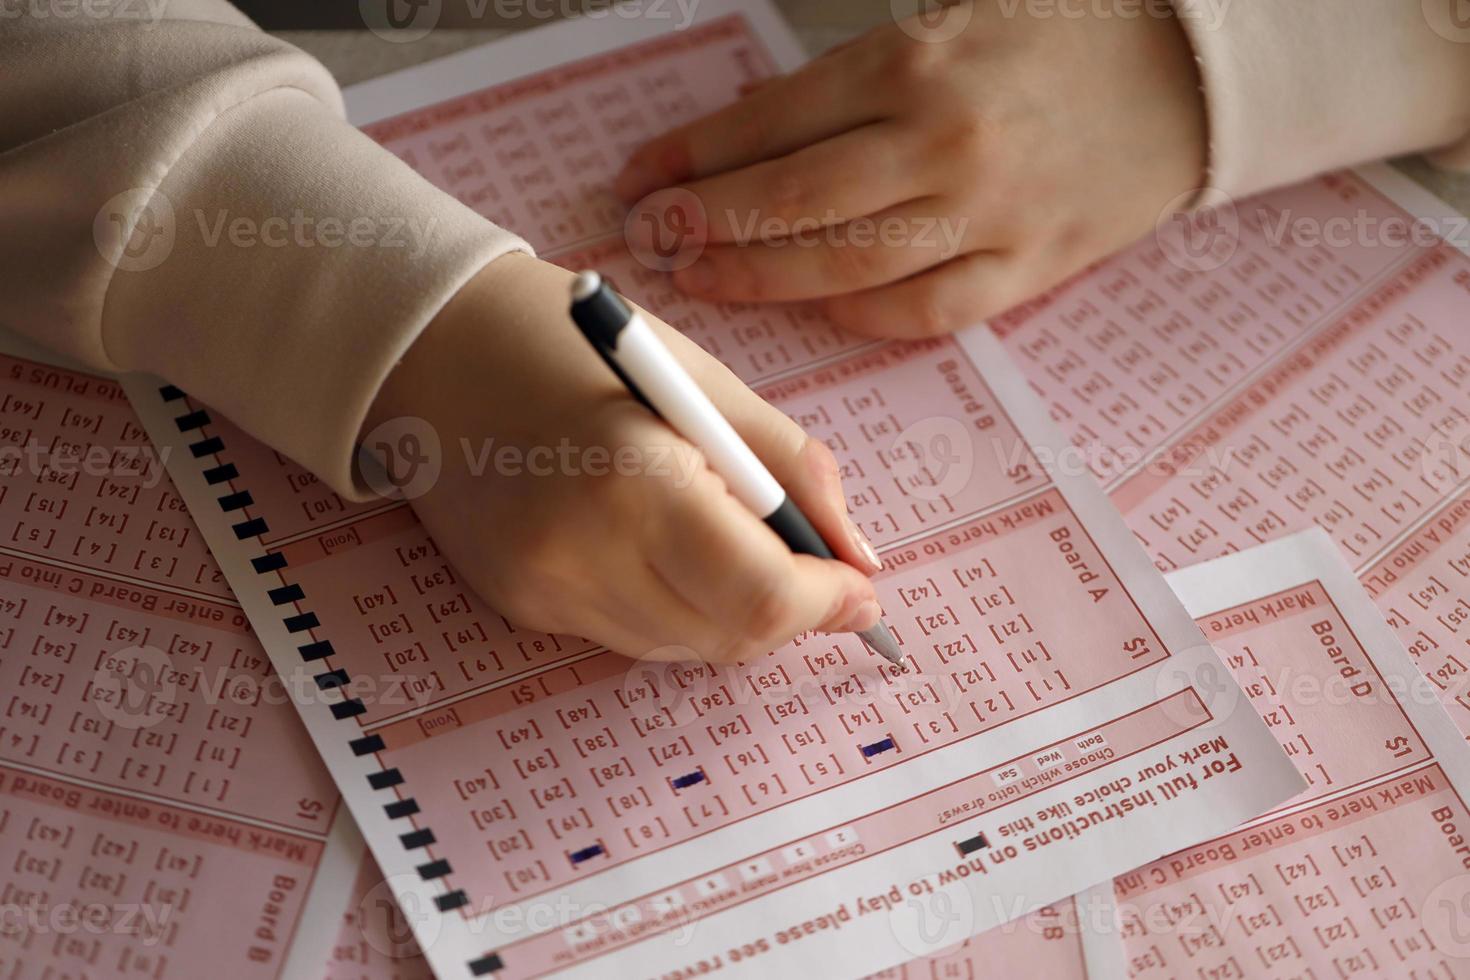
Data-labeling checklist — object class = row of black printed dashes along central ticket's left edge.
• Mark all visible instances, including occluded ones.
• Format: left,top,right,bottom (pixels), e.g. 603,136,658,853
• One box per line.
159,385,504,977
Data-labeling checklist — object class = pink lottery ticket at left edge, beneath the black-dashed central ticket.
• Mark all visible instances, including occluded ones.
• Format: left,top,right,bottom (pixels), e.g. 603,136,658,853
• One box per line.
0,332,362,980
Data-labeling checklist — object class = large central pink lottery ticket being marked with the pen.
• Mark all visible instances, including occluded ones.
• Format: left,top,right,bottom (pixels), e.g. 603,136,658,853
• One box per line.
129,3,1299,977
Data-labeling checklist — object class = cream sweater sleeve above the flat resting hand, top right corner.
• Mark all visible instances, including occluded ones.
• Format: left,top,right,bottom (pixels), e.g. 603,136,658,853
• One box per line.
1173,0,1470,197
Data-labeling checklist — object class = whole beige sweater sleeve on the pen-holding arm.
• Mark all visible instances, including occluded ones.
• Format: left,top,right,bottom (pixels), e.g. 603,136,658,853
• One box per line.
0,0,529,497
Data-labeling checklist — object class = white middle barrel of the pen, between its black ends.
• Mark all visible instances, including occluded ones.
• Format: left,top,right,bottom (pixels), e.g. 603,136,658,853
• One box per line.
614,310,786,519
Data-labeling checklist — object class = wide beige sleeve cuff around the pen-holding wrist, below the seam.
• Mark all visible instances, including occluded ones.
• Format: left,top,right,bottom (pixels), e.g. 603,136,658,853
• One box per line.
103,88,529,500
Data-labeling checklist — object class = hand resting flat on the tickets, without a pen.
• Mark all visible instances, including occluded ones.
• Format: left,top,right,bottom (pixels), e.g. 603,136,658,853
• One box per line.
616,0,1205,336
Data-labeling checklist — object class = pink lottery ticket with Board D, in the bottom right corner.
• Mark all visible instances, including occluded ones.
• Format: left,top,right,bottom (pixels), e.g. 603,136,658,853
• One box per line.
1116,529,1470,977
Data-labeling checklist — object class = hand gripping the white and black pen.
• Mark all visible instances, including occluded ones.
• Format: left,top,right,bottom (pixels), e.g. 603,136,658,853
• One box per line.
365,254,881,663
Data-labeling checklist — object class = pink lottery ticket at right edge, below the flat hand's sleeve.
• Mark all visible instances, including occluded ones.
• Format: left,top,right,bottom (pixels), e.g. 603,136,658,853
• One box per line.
994,167,1470,743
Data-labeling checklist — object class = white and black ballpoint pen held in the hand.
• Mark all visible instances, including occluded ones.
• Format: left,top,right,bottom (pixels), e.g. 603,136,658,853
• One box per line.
572,272,907,670
